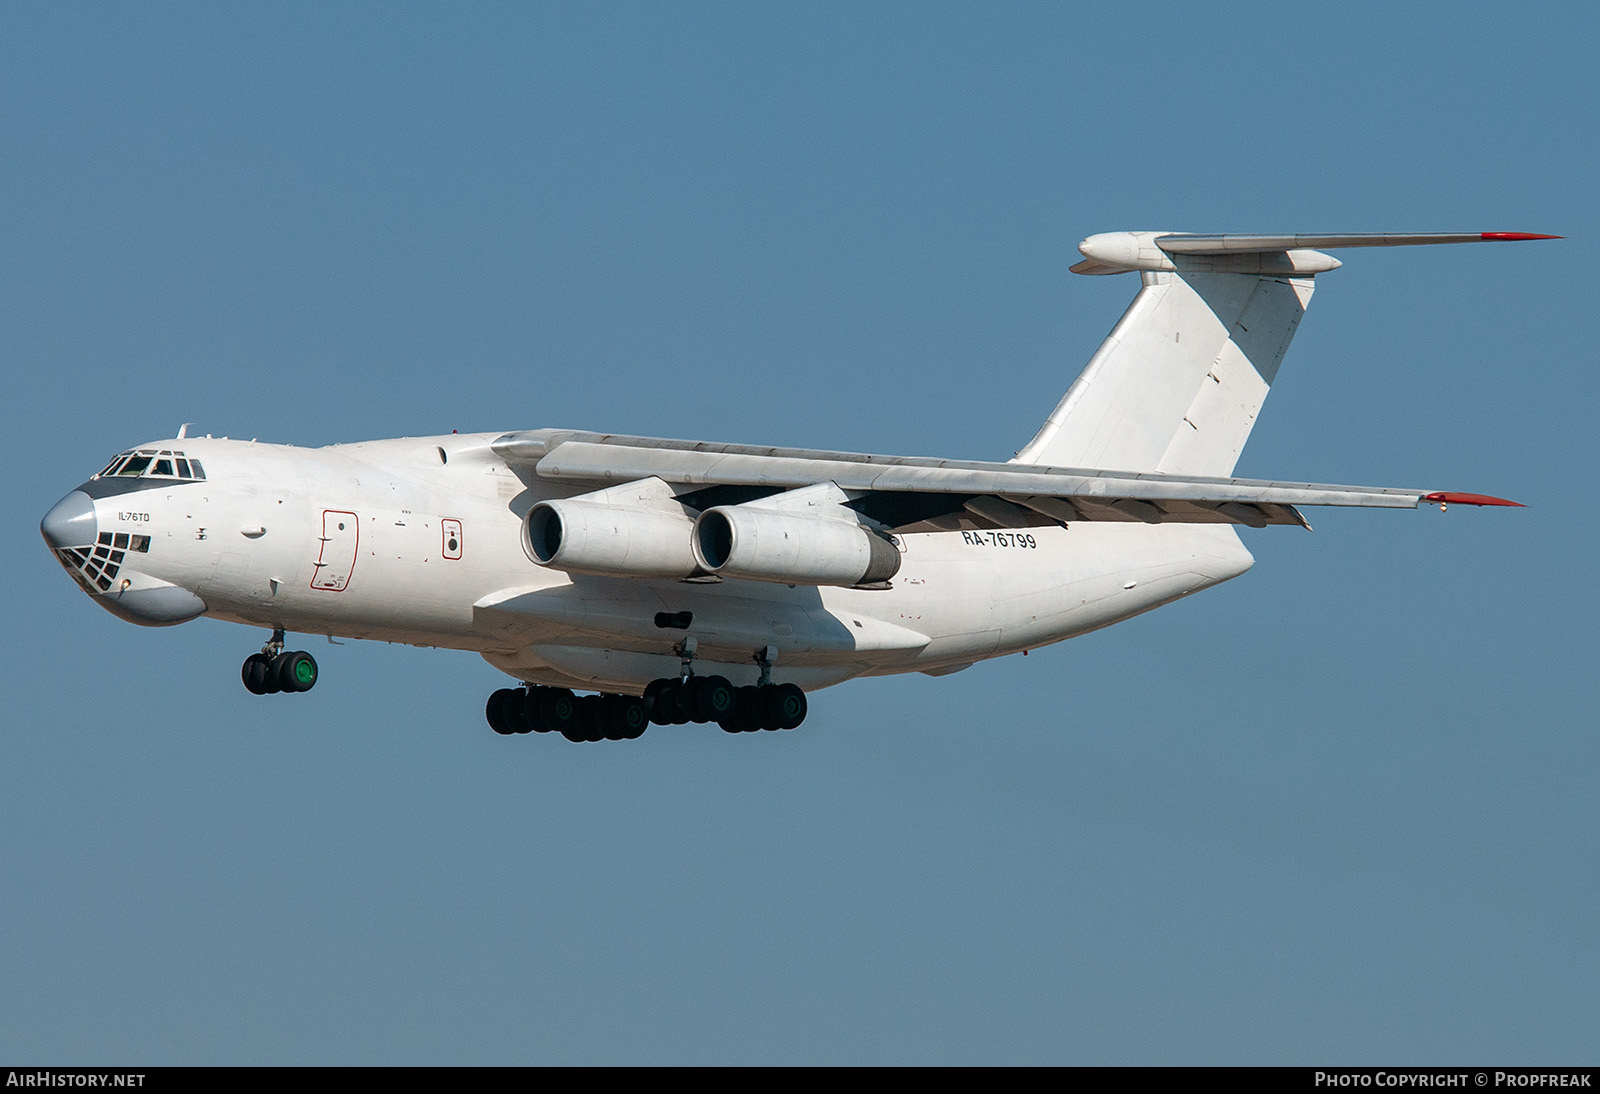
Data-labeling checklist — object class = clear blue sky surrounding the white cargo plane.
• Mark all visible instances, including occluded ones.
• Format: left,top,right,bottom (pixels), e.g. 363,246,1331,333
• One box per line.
0,3,1600,1064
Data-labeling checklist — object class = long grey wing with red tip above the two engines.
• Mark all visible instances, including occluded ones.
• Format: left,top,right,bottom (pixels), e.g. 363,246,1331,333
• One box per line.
494,430,1518,531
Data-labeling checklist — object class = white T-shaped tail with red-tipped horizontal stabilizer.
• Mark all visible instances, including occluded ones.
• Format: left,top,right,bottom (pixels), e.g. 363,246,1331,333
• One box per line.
1013,232,1560,477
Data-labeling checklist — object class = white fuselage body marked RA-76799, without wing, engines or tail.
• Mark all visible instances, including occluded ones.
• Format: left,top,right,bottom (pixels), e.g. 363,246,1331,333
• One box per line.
43,433,1253,694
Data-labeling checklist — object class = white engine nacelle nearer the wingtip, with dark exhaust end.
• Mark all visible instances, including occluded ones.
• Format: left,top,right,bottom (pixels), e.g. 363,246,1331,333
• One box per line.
694,505,899,585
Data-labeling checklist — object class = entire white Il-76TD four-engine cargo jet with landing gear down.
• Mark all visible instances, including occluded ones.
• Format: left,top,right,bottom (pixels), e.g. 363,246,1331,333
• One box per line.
42,232,1558,741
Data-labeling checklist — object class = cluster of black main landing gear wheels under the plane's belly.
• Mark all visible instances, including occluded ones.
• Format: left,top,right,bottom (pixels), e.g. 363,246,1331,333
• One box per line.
483,677,806,741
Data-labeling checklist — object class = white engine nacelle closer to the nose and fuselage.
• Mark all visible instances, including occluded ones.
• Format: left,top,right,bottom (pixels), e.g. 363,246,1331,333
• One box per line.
522,497,701,579
